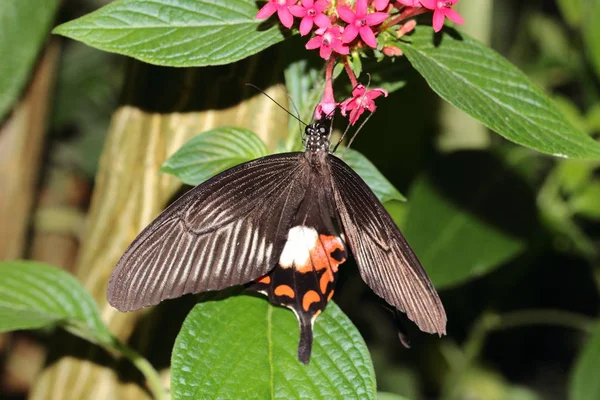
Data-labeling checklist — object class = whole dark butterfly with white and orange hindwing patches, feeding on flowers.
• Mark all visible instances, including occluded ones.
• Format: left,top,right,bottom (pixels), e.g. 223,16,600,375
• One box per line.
107,119,446,364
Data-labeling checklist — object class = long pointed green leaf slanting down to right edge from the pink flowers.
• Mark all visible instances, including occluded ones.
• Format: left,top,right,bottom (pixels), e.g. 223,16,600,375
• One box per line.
398,26,600,159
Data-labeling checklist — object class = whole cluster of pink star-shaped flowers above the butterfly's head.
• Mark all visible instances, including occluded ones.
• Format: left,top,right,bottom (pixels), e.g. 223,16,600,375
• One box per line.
256,0,464,124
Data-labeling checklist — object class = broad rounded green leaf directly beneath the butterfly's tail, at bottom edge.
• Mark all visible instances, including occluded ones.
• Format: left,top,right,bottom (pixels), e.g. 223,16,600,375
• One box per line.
171,296,375,399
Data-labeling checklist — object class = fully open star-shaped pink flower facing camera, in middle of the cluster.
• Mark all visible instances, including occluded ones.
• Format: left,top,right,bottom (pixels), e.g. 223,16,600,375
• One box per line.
337,0,389,47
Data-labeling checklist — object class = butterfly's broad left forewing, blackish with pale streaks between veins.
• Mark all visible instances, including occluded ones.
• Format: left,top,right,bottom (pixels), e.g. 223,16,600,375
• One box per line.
107,153,310,311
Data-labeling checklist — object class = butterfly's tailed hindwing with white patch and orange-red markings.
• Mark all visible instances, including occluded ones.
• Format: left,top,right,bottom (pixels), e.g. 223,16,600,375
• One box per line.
248,170,347,363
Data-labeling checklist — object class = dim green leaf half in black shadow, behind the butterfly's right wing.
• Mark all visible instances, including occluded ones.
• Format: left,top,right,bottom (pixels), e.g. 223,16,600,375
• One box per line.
403,152,536,289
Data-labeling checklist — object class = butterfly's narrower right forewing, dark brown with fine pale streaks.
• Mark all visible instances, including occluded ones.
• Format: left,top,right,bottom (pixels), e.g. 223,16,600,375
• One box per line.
328,155,446,335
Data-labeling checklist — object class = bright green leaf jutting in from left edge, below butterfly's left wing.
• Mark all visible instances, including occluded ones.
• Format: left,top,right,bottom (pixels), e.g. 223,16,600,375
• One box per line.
0,261,111,343
